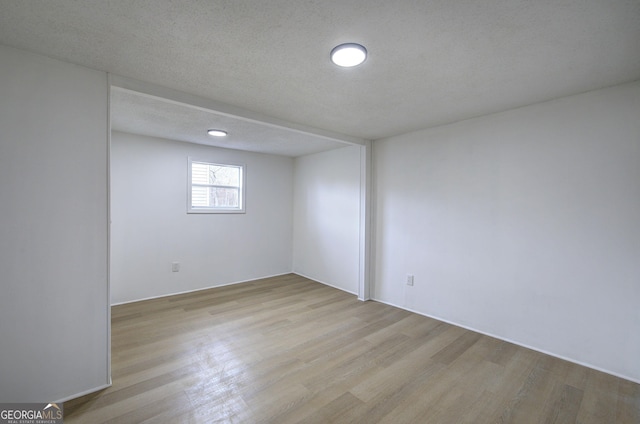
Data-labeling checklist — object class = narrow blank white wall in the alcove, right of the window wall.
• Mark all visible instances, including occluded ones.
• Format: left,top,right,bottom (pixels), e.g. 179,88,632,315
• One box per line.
293,146,361,294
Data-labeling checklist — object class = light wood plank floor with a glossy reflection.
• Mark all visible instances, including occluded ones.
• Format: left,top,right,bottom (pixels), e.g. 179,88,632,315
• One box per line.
64,275,640,424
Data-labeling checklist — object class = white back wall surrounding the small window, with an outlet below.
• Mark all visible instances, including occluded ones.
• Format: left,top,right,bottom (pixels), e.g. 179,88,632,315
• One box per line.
111,132,293,303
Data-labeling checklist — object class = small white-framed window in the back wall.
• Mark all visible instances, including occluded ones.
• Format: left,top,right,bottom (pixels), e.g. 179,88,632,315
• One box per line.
187,158,244,213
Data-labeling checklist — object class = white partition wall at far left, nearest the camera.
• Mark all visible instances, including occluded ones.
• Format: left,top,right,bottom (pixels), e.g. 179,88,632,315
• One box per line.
0,46,110,402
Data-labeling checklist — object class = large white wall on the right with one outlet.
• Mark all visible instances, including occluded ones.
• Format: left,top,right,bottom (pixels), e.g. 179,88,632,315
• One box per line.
374,83,640,381
